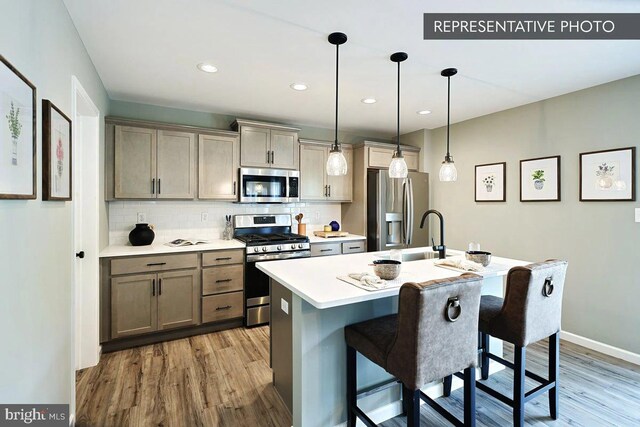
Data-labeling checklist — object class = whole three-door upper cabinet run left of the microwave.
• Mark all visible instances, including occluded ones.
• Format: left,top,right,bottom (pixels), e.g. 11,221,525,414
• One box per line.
105,118,240,201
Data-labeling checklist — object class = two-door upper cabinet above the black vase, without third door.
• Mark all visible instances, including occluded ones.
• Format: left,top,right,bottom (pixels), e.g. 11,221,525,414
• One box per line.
114,125,196,199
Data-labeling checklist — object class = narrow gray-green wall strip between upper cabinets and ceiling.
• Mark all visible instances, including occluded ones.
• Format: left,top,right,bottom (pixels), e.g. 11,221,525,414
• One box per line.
110,100,389,144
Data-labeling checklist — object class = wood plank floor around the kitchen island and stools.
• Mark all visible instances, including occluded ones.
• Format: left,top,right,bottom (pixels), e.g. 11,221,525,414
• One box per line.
76,327,640,427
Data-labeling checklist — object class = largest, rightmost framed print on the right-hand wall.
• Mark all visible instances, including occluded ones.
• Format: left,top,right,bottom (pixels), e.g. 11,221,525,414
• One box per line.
580,147,636,202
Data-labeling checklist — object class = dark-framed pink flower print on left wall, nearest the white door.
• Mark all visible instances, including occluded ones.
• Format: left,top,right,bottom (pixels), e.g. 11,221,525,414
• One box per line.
42,99,72,200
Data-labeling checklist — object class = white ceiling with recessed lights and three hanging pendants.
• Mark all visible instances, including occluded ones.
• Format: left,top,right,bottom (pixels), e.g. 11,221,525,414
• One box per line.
64,0,640,135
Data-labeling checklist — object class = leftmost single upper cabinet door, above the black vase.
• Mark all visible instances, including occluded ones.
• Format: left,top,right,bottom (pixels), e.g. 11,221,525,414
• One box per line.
115,126,157,199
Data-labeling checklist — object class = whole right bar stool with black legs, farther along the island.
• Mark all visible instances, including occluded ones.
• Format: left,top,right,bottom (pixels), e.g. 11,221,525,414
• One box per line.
445,260,567,427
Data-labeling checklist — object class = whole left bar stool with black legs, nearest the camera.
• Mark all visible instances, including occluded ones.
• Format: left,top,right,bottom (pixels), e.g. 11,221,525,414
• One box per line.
344,273,482,427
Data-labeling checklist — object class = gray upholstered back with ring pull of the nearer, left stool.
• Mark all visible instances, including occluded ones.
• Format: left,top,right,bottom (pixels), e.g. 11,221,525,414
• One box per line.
386,273,482,390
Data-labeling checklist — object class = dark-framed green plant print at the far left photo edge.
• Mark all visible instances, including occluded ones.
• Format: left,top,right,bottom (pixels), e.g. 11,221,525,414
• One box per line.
0,55,36,199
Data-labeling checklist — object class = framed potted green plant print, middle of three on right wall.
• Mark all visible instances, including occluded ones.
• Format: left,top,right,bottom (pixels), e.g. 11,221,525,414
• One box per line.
520,156,560,202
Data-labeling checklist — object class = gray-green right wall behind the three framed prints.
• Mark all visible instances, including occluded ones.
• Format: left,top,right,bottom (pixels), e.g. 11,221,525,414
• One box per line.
425,76,640,353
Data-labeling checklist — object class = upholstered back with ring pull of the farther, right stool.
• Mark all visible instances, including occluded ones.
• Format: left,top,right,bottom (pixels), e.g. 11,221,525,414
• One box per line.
489,260,567,347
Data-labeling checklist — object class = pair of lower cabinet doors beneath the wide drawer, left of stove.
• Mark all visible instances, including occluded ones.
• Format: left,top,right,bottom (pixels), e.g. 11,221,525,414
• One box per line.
111,270,200,338
